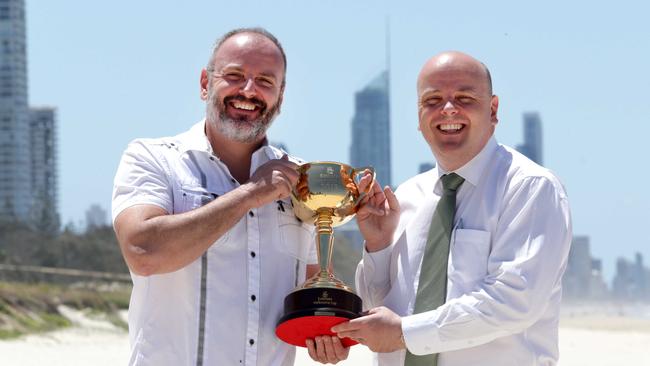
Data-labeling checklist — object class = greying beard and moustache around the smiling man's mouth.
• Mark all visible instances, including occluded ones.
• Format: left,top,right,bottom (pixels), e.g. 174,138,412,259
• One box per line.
206,91,279,143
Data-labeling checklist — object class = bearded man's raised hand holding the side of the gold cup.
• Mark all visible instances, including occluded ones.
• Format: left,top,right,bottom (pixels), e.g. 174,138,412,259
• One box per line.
242,155,299,207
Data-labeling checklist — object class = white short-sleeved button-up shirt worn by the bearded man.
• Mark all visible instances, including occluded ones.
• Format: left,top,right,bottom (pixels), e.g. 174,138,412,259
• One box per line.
112,121,316,366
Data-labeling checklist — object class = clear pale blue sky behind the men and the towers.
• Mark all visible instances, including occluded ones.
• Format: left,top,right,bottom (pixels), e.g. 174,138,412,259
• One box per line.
26,0,650,279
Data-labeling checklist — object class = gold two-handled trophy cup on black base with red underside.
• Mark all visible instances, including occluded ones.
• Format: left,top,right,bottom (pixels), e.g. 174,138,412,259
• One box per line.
275,161,375,347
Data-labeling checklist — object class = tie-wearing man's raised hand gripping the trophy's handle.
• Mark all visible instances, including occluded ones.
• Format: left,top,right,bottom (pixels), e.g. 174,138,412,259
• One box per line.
357,174,400,252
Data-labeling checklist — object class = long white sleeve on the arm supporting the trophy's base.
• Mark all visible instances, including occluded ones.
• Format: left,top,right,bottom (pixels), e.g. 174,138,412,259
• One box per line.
402,177,571,355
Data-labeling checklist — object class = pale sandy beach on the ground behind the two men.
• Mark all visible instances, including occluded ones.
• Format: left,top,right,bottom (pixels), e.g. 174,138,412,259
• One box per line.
0,305,650,366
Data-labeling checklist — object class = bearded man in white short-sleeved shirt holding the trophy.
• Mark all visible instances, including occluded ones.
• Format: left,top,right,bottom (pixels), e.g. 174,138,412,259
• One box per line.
112,28,347,366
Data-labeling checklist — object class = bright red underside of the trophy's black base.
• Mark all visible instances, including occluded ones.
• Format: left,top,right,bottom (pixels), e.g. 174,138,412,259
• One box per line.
275,315,358,347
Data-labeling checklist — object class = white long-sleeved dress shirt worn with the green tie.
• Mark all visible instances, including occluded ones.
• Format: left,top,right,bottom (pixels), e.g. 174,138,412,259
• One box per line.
357,138,571,366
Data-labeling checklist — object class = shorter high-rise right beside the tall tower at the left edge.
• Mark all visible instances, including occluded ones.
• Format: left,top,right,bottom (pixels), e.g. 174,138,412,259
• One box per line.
29,107,59,232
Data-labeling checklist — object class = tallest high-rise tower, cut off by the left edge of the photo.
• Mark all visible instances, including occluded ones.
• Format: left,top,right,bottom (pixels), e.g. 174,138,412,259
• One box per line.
0,0,32,222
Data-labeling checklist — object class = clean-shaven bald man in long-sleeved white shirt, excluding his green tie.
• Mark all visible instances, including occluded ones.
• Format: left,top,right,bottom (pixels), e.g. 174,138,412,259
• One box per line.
333,52,571,366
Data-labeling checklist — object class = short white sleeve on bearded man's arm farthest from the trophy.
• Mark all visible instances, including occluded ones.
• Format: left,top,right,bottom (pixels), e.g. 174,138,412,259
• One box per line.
111,140,173,221
